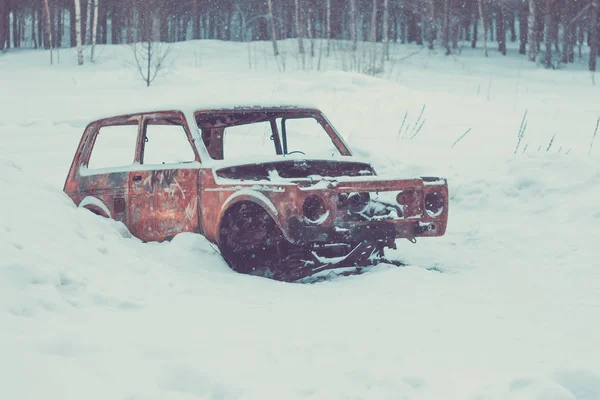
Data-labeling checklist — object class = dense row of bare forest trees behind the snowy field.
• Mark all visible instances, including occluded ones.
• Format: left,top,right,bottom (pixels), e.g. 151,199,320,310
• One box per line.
0,0,600,70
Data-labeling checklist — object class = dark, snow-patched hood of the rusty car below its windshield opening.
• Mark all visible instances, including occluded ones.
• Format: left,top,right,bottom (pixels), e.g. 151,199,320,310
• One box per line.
216,158,375,181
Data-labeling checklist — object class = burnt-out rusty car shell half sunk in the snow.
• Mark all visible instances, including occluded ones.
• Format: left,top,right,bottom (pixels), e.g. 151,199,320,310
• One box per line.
64,107,448,281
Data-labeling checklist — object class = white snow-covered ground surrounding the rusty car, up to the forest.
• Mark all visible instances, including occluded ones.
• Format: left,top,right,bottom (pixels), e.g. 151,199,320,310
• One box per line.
0,42,600,400
